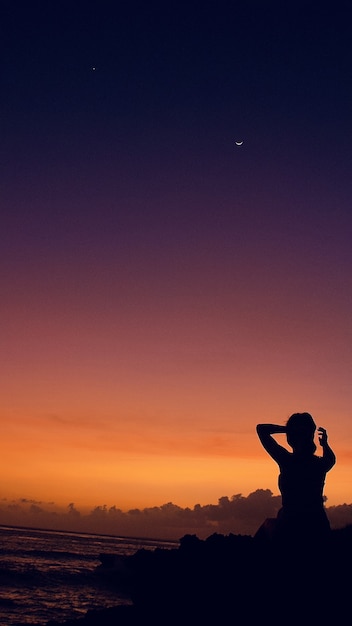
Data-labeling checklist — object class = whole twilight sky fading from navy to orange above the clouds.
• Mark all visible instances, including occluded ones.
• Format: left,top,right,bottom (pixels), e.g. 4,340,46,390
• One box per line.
0,0,352,521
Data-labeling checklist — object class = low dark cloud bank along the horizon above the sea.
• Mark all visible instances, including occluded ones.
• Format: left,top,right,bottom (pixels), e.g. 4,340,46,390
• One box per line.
0,489,352,540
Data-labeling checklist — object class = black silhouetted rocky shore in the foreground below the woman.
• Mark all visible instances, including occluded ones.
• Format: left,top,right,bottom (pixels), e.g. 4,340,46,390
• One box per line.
22,525,352,626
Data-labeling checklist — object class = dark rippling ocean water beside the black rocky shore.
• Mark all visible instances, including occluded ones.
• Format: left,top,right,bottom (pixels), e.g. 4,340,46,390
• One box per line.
0,526,177,626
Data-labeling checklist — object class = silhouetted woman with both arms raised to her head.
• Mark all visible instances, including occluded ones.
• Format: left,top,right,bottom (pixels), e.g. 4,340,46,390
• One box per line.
257,413,336,543
